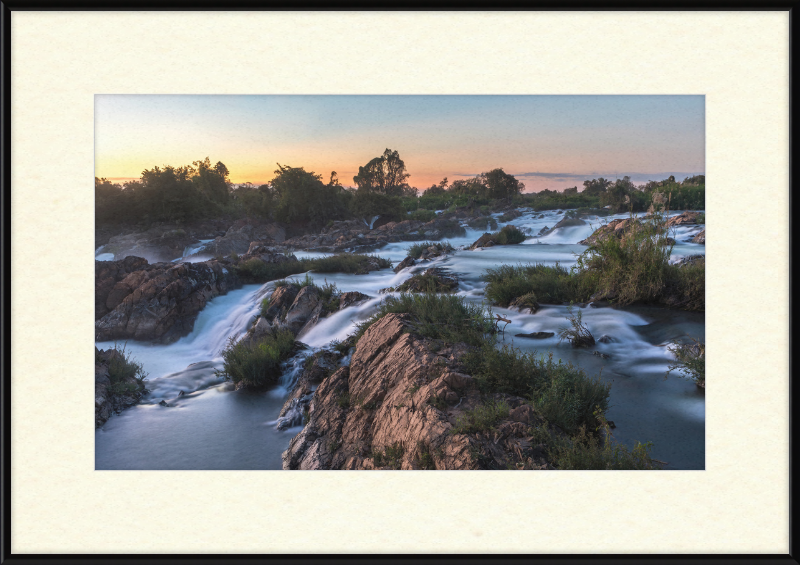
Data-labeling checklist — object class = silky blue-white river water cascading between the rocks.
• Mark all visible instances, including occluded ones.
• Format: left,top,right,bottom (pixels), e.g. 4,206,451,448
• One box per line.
95,211,705,470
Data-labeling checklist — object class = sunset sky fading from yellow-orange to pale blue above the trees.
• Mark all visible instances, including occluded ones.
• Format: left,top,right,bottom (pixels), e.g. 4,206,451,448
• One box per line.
95,95,705,191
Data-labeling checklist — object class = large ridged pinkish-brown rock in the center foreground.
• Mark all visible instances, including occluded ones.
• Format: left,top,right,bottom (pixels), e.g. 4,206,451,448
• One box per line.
283,314,552,469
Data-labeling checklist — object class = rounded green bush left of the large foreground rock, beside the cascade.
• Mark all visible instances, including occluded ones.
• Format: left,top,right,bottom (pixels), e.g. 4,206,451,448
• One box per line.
216,330,295,388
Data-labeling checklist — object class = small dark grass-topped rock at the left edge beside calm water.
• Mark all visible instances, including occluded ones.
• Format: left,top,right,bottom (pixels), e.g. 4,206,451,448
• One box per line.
94,347,147,428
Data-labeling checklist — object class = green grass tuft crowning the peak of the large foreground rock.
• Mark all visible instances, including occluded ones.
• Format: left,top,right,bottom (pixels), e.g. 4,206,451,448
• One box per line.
355,294,494,345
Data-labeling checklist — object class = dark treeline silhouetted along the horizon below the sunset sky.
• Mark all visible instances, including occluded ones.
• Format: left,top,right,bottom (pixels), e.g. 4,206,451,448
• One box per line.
95,149,705,229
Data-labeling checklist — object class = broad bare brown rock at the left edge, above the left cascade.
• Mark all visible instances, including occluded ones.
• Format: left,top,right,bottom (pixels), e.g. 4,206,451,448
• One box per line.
95,257,238,343
